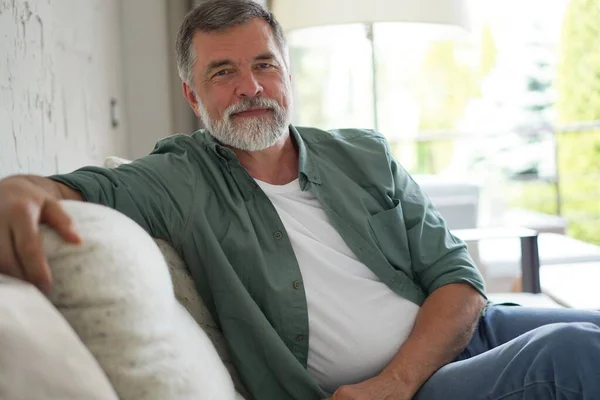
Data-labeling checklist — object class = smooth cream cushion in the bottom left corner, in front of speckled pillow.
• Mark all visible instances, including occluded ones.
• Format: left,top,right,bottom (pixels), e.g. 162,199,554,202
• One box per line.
0,275,117,400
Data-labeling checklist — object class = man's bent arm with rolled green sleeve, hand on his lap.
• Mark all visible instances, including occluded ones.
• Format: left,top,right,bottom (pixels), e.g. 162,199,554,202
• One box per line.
333,139,486,400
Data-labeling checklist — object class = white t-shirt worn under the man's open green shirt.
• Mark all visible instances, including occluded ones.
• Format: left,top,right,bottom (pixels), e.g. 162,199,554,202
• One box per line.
256,180,419,391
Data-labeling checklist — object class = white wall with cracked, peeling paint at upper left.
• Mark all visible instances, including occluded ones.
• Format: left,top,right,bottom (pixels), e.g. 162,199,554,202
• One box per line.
0,0,129,177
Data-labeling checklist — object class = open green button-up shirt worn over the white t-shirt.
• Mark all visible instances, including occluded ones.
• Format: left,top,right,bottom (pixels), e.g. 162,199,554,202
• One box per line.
52,127,484,400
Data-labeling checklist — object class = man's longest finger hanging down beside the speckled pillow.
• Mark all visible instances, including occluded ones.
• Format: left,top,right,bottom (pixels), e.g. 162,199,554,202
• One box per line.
12,204,52,292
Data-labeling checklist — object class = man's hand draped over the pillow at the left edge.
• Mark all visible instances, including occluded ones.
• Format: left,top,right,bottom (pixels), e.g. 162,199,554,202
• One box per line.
0,176,82,292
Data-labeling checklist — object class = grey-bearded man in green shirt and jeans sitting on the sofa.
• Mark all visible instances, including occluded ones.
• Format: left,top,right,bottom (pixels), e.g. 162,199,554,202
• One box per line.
0,0,600,400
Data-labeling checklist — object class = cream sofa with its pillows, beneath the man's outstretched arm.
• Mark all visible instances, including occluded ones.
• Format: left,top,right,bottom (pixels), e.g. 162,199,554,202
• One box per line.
0,201,247,400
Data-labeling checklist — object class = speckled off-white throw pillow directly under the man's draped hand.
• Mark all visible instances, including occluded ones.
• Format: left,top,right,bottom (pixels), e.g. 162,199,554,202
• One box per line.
43,201,243,400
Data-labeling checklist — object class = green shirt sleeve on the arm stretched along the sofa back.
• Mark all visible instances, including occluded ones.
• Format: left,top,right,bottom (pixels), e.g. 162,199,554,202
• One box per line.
49,135,196,247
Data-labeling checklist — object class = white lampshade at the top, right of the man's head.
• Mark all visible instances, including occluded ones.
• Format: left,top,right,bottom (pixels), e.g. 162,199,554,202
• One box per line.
271,0,469,32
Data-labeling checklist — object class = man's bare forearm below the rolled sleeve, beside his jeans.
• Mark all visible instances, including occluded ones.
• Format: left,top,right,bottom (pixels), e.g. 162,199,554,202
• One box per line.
380,283,485,397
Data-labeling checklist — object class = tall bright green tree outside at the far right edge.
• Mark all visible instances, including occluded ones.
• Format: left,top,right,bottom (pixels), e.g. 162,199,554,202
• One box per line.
557,0,600,244
